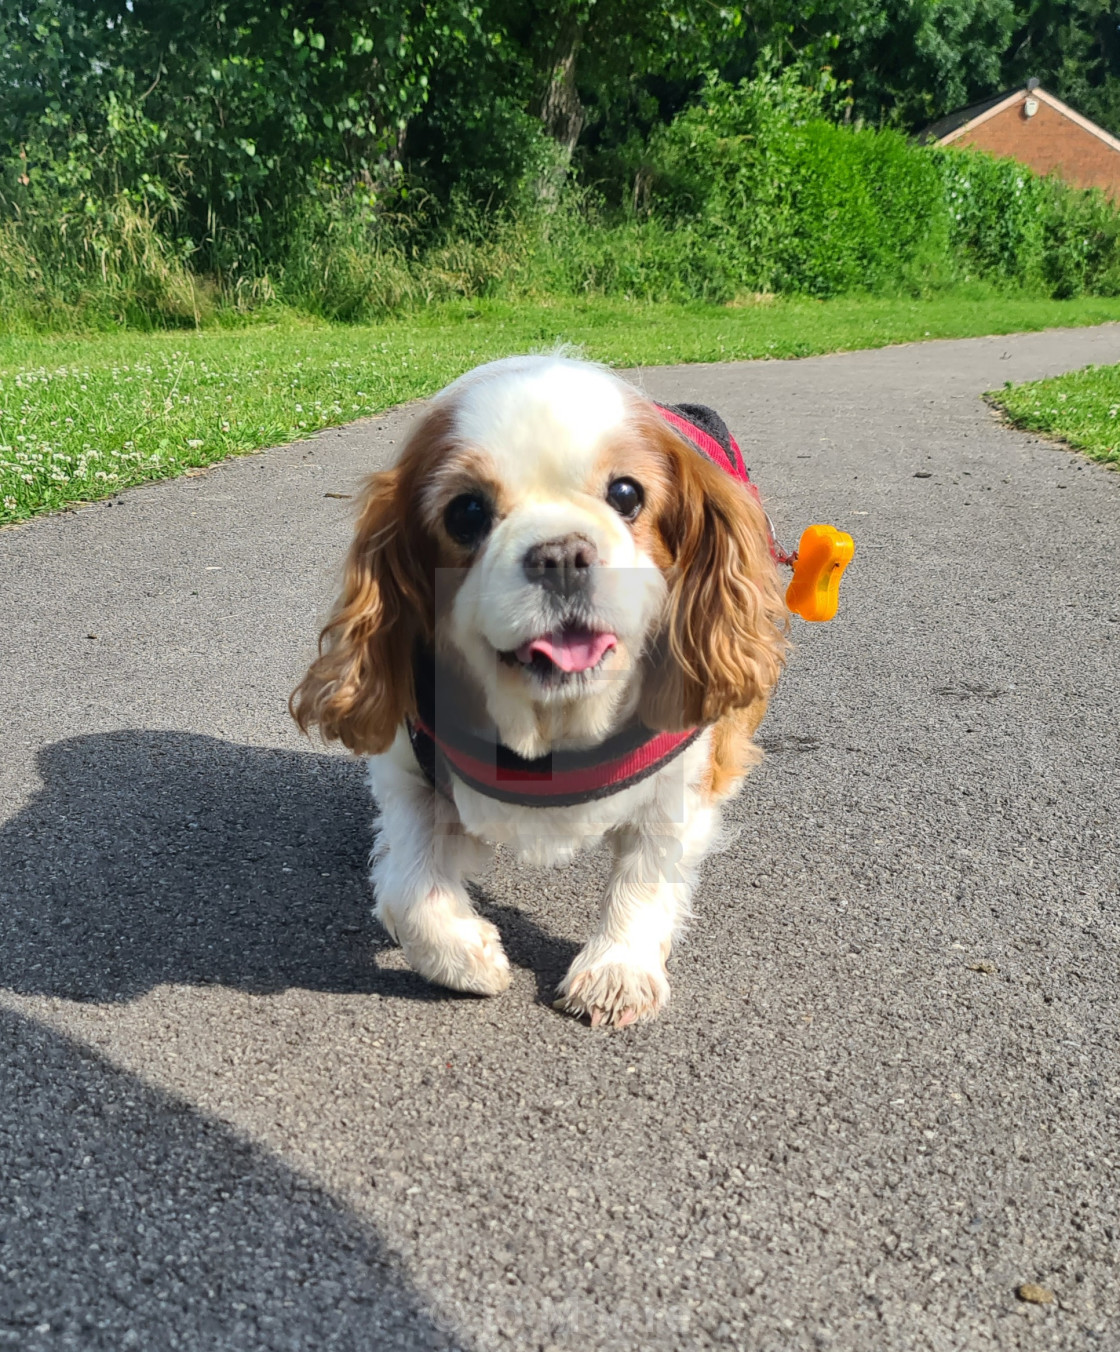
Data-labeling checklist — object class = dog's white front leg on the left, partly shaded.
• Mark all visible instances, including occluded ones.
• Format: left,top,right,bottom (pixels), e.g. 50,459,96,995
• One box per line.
369,748,510,995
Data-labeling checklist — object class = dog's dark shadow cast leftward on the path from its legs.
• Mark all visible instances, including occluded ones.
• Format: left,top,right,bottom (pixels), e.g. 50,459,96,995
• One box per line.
0,731,575,1002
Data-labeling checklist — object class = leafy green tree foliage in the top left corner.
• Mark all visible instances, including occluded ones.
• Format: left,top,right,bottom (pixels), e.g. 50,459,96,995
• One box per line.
0,0,489,252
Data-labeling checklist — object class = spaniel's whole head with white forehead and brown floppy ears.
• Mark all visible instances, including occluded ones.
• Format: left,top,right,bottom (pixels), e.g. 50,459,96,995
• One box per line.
292,357,786,756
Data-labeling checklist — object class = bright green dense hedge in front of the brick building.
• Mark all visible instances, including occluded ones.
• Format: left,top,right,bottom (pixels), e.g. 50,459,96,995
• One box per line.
647,74,1120,296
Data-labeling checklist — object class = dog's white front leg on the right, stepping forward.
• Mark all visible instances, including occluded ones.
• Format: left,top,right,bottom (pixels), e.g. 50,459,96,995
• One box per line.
556,795,718,1028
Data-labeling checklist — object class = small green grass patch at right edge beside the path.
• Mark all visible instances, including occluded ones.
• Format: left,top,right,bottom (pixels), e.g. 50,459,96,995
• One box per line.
989,366,1120,465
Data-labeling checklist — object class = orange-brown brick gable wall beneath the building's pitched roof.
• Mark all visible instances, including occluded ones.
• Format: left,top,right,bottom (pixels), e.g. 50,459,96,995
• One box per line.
952,95,1120,201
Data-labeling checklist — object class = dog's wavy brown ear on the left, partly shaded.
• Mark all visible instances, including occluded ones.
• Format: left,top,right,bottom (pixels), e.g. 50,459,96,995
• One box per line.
288,461,431,756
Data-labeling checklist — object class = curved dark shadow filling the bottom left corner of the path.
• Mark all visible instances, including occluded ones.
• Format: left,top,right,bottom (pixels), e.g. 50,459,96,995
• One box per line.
0,1010,464,1352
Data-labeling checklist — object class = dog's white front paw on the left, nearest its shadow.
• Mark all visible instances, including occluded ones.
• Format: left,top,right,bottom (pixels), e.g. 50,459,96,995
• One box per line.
381,899,510,995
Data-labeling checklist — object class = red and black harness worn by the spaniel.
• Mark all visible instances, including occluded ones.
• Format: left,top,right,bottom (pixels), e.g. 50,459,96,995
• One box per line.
409,404,768,807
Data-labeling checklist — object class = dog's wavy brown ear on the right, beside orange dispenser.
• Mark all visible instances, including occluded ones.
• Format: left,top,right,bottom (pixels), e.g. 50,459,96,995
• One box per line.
641,415,789,729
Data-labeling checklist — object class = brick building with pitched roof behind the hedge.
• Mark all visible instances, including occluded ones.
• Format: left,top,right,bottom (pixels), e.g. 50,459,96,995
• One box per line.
921,80,1120,201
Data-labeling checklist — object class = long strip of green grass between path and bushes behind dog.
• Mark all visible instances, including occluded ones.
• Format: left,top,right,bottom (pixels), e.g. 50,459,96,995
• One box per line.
0,292,1120,523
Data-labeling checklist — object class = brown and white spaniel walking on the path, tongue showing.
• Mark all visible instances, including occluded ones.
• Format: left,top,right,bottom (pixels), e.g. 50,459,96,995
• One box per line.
291,356,789,1026
